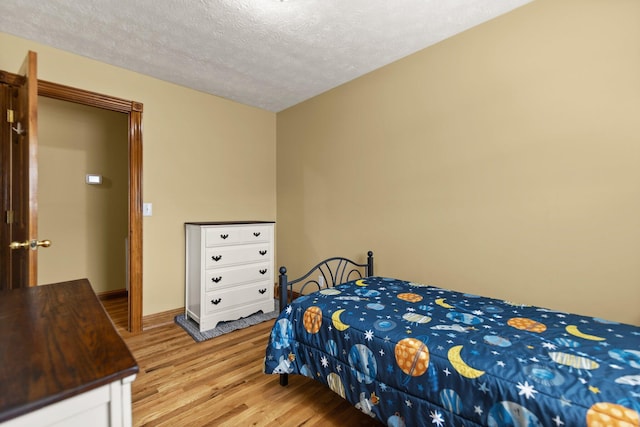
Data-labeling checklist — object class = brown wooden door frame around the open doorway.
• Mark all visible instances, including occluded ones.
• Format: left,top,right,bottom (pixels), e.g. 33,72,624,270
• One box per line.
0,71,143,333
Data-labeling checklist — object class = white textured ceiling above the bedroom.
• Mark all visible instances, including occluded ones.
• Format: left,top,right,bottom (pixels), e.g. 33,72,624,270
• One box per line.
0,0,531,112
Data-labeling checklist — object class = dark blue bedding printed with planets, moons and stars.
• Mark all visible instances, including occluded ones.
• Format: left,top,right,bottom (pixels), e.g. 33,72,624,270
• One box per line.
264,277,640,427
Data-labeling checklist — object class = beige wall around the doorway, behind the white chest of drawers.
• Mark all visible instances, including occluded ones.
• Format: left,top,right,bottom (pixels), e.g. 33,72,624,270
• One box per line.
0,33,276,315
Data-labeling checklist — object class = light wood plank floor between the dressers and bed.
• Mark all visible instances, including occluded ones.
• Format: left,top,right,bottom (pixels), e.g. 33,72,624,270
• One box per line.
102,298,381,427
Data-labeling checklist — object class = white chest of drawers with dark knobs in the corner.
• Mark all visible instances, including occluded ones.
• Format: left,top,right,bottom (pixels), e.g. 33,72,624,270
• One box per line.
185,221,275,332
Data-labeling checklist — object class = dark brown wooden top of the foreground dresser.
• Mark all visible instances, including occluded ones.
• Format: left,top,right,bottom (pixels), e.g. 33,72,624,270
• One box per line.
0,279,138,422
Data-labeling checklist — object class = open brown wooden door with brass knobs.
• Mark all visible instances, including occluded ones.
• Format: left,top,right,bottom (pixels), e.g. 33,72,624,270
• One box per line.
0,51,43,289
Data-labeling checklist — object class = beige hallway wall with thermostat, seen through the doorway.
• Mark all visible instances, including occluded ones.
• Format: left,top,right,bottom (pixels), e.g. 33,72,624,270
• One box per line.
38,97,129,292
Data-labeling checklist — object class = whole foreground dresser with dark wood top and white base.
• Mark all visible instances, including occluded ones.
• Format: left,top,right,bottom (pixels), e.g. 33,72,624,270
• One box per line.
0,279,138,427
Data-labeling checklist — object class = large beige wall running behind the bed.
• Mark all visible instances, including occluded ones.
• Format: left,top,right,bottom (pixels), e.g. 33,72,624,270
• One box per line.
276,0,640,324
